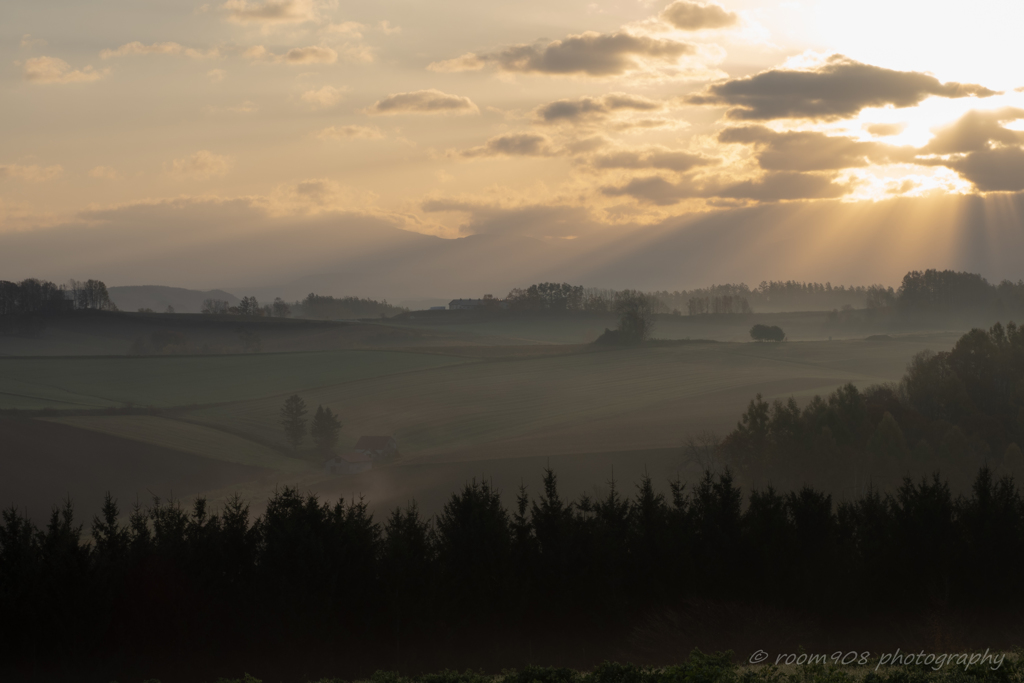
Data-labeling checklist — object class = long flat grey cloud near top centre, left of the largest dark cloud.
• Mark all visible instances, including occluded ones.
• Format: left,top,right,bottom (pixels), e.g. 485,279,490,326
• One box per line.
487,32,696,76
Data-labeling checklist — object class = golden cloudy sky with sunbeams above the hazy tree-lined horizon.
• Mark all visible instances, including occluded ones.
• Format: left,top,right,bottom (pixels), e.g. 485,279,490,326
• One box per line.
0,0,1024,296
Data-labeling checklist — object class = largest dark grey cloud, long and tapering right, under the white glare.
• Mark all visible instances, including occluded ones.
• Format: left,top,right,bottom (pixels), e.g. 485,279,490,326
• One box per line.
685,54,996,121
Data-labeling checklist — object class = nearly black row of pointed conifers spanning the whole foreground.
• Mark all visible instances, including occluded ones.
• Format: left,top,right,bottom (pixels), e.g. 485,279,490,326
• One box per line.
0,469,1024,666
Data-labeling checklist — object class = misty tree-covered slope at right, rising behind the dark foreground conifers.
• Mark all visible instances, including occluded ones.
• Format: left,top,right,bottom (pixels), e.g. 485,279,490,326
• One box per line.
722,323,1024,495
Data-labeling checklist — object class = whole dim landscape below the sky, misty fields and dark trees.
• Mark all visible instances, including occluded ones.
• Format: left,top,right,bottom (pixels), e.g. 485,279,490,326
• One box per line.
0,270,1024,682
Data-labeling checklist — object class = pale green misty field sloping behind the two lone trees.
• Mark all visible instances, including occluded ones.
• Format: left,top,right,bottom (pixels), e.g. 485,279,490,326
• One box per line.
189,337,952,460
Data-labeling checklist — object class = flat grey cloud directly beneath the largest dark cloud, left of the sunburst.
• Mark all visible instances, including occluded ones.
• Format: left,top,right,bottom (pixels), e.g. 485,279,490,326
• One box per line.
718,126,913,171
